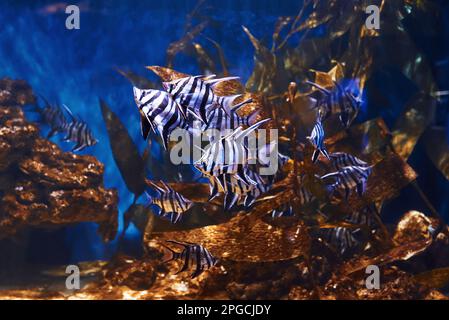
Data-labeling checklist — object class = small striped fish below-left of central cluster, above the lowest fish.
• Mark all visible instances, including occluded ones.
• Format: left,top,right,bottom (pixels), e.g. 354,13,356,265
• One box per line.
147,181,193,223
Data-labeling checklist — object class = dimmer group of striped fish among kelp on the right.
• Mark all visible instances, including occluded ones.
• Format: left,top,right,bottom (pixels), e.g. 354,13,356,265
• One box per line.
304,81,377,255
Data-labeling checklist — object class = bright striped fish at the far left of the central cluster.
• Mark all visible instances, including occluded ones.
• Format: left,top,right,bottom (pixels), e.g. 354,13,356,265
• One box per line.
134,87,187,149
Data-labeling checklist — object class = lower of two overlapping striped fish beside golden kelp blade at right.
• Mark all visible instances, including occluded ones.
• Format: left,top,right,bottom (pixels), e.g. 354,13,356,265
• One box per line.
321,166,372,199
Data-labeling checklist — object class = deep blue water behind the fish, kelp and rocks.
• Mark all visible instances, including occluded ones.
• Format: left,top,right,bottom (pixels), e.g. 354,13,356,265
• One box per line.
0,0,449,263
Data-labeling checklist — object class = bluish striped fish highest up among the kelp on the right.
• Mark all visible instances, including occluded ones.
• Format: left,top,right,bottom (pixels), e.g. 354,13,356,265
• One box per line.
307,81,362,128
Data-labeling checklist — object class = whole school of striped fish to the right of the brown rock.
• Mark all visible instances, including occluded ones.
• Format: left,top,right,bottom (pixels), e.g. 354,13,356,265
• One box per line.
133,75,372,277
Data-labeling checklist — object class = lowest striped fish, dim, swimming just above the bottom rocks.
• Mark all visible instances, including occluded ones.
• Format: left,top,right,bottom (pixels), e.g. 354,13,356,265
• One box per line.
164,240,218,279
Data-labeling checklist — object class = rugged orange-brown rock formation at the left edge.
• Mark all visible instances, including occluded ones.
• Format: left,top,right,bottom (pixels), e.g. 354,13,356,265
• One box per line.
0,79,118,240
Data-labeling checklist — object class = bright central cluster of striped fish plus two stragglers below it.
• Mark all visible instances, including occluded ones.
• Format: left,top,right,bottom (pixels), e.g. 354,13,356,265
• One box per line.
133,75,282,277
